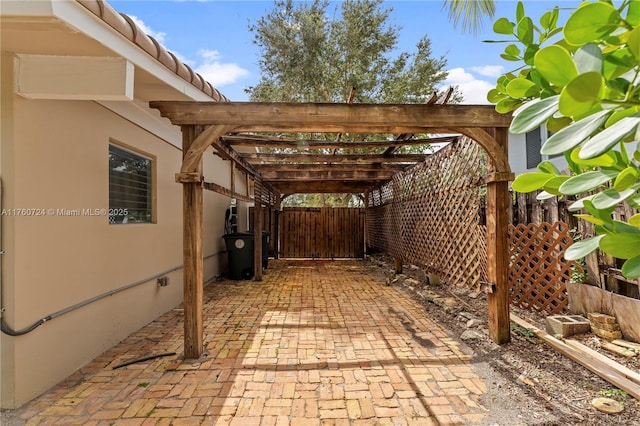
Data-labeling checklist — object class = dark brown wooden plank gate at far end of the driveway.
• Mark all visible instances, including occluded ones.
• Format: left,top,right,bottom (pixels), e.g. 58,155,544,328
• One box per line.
280,207,365,259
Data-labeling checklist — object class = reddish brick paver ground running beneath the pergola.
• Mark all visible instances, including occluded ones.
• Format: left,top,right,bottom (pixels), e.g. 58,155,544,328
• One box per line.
8,260,488,426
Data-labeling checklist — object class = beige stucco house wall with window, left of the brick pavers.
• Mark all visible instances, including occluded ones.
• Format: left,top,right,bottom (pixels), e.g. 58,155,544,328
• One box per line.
0,1,246,408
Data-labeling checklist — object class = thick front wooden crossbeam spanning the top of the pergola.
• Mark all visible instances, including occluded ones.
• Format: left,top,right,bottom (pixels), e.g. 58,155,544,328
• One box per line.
149,101,511,130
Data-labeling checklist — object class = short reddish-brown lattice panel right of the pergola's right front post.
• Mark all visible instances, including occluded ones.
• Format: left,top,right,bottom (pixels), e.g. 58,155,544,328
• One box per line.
509,222,581,315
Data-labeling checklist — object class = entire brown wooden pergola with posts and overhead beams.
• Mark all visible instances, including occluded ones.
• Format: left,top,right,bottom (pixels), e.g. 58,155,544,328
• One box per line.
150,101,513,358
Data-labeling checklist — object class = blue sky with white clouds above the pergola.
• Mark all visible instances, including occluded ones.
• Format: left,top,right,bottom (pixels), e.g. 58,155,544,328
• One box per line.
109,0,579,104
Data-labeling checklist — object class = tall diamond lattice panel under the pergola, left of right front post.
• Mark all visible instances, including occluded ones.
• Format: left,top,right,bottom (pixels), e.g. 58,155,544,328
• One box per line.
367,137,486,288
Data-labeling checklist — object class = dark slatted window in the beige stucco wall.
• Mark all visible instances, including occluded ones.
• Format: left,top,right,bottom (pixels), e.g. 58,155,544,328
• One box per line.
109,144,153,223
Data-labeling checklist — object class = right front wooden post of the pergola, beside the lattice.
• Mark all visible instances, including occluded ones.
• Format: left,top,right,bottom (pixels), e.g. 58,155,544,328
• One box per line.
487,128,511,344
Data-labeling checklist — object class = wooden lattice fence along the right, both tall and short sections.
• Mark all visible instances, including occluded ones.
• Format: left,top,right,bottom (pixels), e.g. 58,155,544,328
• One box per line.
366,138,581,314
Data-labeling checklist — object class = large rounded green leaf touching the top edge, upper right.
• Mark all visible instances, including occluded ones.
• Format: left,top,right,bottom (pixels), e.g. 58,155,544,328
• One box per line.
564,2,620,46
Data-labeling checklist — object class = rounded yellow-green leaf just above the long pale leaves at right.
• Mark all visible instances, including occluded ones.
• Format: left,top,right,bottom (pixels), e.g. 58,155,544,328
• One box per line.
558,71,605,117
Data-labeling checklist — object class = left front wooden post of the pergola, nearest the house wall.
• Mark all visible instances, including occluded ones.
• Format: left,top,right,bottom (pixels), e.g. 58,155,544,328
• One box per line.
182,126,204,359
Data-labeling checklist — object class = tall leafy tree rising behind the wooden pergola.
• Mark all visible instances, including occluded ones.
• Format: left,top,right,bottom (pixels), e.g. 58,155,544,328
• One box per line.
247,0,460,205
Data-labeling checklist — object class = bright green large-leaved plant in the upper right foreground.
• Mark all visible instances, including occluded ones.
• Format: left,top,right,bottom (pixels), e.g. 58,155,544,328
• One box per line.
488,0,640,278
